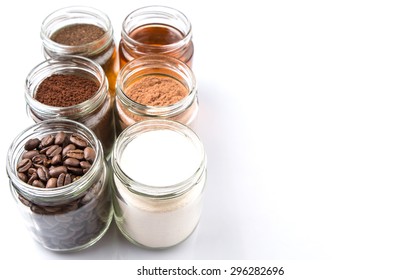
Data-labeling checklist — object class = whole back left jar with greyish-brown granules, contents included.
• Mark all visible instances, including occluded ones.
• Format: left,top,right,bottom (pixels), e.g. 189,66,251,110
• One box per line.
41,6,119,95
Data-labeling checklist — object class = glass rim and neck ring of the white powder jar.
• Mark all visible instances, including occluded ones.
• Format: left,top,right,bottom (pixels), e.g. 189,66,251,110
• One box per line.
111,120,207,199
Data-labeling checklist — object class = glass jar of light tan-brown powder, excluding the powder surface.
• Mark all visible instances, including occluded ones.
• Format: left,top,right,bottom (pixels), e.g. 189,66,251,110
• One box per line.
115,55,198,135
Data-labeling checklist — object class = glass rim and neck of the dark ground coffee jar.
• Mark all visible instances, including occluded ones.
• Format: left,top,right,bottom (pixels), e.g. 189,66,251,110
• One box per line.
25,55,108,119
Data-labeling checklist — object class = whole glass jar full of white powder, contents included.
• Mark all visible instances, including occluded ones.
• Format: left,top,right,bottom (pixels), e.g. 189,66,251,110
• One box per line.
111,120,207,248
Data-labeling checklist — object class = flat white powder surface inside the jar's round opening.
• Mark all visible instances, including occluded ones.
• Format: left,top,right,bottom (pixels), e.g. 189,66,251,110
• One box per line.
120,129,200,187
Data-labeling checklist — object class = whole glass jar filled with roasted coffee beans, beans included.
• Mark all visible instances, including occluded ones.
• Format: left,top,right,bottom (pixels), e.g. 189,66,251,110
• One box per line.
6,119,113,251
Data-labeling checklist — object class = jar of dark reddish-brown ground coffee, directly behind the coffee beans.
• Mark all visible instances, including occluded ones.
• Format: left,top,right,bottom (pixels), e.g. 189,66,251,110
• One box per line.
25,56,116,156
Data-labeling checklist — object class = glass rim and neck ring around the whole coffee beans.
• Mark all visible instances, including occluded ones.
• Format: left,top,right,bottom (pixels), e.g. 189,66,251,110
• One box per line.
6,119,103,205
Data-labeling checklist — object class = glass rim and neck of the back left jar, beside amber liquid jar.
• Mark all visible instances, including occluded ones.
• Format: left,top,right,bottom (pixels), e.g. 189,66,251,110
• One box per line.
40,6,114,57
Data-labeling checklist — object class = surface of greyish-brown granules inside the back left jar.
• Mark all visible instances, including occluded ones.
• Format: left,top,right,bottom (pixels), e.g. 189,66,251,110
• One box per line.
50,23,105,46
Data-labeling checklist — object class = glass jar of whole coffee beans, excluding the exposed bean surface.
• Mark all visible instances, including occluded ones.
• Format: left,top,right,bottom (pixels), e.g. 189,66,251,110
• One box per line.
6,119,113,251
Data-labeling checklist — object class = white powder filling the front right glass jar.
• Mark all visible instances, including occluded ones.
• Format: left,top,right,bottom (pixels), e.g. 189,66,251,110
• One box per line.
114,126,206,248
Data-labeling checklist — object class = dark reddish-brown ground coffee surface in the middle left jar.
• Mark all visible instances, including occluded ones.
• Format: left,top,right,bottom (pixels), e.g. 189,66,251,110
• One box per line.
35,74,99,107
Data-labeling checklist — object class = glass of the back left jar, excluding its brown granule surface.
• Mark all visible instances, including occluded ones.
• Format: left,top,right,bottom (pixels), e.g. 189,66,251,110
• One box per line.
41,6,119,95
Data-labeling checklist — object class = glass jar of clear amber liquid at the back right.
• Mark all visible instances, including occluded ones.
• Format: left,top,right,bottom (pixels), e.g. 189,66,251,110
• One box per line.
119,6,194,67
